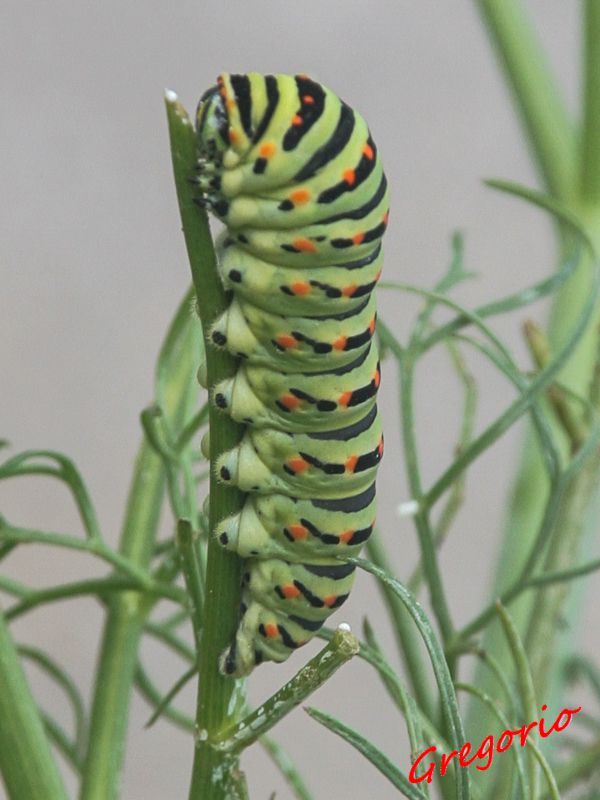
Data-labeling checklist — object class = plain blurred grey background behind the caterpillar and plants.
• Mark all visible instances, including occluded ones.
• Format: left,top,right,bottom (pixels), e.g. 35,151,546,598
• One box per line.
0,0,600,800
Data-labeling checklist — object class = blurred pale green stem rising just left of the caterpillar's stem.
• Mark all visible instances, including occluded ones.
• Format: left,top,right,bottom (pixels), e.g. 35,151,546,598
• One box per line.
80,316,198,800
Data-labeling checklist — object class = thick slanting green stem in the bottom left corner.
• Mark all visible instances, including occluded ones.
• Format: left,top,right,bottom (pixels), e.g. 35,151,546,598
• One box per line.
0,611,67,800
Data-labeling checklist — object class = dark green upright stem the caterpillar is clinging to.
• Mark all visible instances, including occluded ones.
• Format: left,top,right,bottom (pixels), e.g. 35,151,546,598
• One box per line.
166,95,243,800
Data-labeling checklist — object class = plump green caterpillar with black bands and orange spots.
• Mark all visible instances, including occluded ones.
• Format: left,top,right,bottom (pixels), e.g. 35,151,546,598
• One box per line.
196,72,388,676
